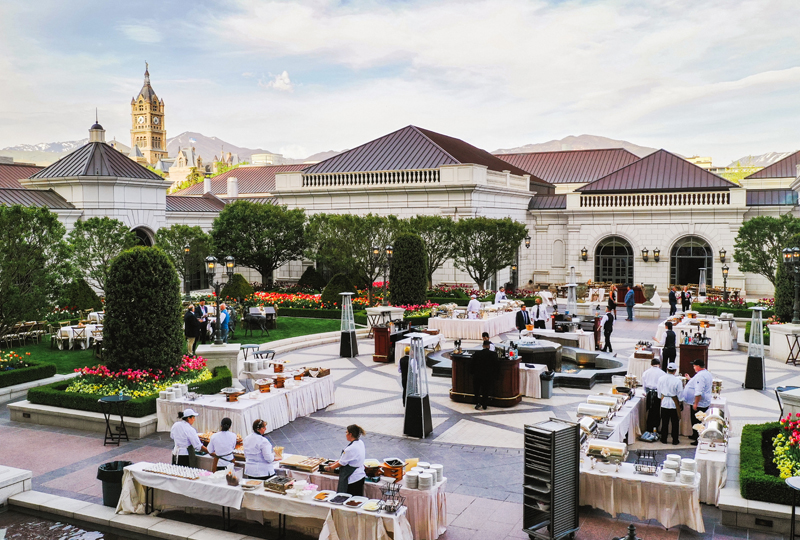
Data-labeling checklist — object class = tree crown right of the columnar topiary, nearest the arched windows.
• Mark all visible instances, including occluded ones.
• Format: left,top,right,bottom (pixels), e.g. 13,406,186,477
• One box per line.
452,217,527,290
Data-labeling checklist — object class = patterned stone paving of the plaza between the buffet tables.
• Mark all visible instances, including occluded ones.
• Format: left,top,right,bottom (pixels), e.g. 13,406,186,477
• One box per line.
0,310,800,540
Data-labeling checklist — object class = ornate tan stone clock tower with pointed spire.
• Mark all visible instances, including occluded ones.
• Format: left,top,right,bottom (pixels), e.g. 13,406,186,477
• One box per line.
131,62,167,165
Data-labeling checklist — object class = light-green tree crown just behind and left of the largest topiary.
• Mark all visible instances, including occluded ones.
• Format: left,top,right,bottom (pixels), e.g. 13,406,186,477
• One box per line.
69,216,136,293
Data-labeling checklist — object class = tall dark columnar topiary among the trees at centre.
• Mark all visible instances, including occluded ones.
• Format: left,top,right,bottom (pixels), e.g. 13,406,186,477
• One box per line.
389,233,428,306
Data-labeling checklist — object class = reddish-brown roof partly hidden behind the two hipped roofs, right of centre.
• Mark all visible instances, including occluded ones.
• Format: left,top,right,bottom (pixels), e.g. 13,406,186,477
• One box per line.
495,148,639,184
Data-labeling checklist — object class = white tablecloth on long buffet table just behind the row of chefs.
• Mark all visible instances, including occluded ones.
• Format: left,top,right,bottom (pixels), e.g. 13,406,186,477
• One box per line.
156,376,335,436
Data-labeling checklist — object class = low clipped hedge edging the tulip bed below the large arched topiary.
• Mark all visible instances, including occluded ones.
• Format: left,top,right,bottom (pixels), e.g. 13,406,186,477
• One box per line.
28,366,232,418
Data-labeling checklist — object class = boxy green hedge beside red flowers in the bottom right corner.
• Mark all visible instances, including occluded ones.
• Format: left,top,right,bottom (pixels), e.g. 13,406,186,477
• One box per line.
739,422,792,504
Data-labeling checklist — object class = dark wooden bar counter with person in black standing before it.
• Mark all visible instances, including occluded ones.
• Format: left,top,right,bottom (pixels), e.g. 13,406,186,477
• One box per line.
450,349,522,407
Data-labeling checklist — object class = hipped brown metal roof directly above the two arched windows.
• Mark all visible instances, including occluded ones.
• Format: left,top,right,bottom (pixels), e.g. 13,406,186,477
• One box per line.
576,150,739,193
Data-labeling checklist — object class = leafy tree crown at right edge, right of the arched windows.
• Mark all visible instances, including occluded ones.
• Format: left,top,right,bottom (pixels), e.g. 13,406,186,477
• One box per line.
733,214,800,285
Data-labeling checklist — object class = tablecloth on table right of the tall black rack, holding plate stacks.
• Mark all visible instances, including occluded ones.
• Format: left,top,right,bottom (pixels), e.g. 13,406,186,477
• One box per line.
580,458,705,533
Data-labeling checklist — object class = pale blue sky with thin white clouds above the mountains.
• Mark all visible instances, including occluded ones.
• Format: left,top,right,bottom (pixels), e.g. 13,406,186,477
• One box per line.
0,0,800,165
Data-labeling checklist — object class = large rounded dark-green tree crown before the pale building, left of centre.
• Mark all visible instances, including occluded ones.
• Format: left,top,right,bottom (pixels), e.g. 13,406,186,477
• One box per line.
211,201,306,285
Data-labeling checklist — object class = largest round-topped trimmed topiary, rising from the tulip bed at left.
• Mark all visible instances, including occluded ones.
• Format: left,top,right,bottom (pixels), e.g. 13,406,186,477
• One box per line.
103,246,185,371
